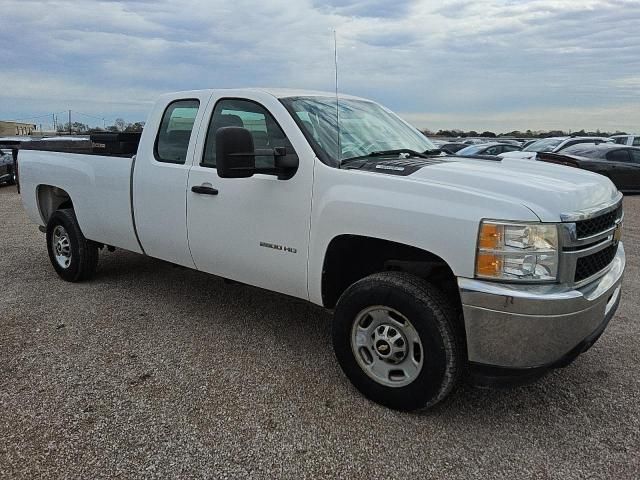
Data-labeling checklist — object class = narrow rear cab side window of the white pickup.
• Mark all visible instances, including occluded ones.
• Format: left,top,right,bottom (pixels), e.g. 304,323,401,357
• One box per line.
154,100,200,164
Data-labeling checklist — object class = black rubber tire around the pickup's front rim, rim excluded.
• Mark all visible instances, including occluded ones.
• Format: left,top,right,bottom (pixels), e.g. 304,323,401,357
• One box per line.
333,272,464,411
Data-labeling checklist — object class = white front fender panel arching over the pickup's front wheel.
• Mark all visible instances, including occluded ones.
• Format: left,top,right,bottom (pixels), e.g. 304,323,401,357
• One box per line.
308,162,539,305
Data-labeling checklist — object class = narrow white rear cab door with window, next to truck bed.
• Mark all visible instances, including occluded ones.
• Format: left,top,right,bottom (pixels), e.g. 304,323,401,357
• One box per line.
133,91,211,268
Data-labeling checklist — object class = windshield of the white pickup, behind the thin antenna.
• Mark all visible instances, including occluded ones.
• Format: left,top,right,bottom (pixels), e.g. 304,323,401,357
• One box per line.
281,97,436,166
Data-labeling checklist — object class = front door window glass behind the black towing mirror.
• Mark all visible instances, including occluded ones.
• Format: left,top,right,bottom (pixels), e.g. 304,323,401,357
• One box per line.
201,99,293,168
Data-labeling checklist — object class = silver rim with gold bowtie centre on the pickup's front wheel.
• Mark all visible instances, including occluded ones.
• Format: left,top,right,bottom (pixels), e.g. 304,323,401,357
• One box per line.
351,305,424,387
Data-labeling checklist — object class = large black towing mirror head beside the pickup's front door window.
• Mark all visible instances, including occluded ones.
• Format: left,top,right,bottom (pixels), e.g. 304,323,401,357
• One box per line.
216,127,256,178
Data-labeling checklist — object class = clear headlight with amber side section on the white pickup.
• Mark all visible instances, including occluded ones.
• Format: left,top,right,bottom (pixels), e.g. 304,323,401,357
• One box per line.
476,221,558,282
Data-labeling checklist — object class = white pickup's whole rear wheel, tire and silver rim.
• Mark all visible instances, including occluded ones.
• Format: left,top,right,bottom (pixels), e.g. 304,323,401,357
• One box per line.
47,209,98,282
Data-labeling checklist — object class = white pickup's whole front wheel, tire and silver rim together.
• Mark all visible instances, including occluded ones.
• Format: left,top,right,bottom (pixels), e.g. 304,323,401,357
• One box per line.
333,272,464,410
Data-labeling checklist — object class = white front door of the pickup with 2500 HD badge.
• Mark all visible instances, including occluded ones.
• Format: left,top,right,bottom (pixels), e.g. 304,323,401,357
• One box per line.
187,92,315,299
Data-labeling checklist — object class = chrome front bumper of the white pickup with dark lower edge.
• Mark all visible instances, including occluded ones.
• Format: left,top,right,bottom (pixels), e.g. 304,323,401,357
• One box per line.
458,243,625,372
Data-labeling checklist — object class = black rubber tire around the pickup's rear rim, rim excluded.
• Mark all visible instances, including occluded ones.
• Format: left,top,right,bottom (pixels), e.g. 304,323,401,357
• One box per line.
47,208,98,282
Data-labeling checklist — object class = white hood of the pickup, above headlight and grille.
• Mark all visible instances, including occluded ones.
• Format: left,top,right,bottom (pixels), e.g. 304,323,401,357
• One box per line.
404,157,619,222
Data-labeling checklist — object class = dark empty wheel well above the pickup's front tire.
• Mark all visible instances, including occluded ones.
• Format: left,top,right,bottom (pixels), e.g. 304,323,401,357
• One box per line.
322,235,460,309
